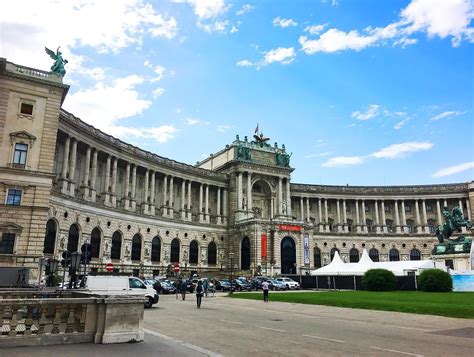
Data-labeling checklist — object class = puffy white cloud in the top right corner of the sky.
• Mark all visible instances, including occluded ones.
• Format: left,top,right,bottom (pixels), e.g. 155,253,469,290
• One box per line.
401,0,474,46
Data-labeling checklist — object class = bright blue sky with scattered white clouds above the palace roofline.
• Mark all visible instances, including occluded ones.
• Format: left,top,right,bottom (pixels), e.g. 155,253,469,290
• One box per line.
0,0,474,185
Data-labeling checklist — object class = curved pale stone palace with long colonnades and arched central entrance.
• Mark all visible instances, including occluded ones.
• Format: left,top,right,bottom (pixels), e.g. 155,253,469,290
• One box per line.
0,58,474,279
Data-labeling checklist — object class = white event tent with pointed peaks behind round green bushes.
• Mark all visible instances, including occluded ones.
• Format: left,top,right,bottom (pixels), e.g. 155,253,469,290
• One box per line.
311,249,440,276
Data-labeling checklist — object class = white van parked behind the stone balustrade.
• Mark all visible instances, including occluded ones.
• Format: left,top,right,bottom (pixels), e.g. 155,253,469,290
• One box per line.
87,275,159,308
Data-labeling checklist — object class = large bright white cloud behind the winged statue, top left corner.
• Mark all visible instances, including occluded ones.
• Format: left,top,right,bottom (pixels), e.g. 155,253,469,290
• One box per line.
0,0,177,73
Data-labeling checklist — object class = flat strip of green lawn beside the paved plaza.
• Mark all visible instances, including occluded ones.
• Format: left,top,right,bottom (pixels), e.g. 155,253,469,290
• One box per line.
231,291,474,319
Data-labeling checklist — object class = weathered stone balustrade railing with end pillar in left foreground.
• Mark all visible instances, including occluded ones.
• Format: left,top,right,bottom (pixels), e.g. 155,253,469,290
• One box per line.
0,290,145,348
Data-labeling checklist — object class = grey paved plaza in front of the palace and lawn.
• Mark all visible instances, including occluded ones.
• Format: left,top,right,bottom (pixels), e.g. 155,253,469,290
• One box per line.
2,295,474,356
